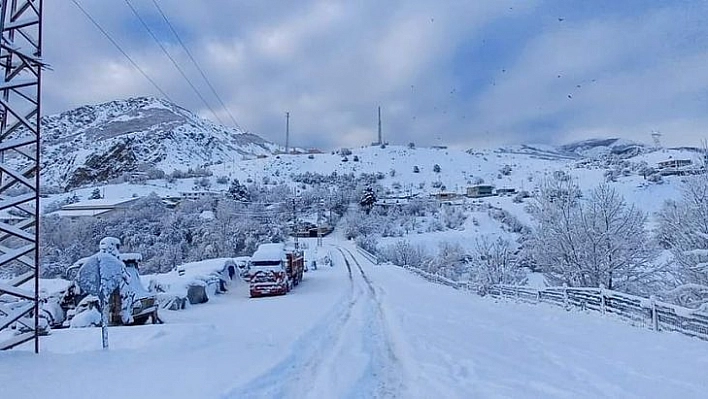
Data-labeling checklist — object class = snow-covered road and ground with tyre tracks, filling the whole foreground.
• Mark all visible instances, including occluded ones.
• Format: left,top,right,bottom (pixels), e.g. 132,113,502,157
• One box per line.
0,241,708,399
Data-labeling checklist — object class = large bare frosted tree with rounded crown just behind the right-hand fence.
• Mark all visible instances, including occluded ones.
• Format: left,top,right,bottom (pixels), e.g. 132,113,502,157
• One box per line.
527,175,657,291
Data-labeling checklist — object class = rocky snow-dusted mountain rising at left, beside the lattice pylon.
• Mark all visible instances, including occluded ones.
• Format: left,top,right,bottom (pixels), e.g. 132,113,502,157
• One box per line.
42,97,279,190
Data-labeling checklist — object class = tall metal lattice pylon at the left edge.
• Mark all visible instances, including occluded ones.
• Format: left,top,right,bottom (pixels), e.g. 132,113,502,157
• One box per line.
0,0,43,352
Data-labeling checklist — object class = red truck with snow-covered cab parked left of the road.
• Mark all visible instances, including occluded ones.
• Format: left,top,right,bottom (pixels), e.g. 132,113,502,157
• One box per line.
248,243,305,298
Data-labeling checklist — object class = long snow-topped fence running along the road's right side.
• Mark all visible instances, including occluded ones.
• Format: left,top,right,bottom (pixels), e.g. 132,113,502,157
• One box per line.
357,246,708,340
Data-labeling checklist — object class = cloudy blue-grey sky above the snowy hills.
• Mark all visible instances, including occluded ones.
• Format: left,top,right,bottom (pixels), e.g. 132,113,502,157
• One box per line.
43,0,708,149
